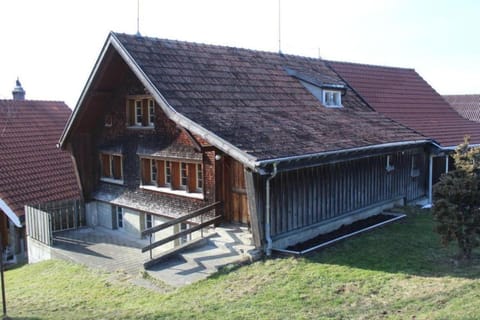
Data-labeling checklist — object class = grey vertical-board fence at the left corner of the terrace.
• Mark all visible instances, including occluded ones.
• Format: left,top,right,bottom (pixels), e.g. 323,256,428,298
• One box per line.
25,199,85,246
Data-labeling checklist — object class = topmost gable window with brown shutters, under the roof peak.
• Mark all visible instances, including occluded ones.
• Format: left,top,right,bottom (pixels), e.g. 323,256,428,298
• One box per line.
127,96,155,128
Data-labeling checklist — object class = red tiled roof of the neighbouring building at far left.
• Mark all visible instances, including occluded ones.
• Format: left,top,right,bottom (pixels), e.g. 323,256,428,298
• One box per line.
0,100,80,216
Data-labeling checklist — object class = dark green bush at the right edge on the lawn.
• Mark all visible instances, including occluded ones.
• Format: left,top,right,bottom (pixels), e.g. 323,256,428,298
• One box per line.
432,138,480,259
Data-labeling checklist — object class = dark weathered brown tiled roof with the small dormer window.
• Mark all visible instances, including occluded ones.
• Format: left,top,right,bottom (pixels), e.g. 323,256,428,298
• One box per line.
114,34,424,160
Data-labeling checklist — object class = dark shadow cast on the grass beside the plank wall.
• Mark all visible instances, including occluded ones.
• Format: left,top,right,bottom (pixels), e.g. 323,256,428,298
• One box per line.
304,211,480,279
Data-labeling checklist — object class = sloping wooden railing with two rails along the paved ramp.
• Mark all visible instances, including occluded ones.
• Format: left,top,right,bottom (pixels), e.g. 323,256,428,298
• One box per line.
142,201,223,259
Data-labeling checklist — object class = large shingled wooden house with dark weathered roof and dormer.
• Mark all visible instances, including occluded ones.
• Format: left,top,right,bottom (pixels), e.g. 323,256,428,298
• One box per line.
60,33,436,254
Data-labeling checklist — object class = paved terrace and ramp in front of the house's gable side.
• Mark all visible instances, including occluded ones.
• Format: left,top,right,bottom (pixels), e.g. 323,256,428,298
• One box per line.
44,225,255,287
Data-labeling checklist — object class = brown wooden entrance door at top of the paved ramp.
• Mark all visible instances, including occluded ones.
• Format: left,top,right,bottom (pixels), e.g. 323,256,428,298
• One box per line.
224,157,250,224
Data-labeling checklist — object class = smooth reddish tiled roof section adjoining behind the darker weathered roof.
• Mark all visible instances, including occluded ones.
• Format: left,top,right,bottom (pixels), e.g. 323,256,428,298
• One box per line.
327,61,480,147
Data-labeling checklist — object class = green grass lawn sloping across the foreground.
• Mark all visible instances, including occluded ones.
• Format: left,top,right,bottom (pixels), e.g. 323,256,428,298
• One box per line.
5,212,480,319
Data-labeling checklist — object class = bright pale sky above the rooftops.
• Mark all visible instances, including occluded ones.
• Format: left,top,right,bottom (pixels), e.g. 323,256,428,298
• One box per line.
0,0,480,109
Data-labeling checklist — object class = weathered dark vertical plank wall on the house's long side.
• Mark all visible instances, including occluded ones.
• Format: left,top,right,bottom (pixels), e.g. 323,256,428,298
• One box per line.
268,150,428,236
